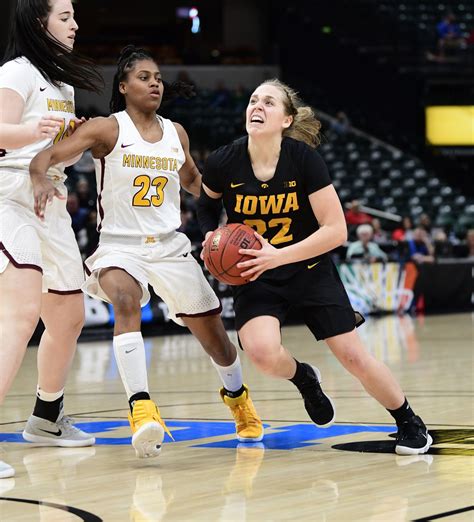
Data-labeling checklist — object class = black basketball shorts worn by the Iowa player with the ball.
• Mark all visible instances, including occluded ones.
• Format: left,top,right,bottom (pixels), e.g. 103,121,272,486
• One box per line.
233,257,364,341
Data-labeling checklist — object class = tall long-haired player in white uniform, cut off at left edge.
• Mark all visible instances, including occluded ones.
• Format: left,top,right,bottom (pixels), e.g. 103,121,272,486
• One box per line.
0,0,100,477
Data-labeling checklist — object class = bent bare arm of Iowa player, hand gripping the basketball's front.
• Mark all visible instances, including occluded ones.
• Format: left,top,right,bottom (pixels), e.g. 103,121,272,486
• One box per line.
237,185,347,281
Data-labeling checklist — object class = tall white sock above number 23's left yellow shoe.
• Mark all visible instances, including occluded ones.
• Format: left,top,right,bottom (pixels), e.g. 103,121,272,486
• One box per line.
113,332,148,399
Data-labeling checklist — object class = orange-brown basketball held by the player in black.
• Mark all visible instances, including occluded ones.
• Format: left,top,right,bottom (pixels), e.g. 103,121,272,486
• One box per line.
204,223,262,286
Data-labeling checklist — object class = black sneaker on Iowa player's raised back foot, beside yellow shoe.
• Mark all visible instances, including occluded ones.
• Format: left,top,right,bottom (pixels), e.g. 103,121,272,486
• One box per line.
298,363,336,428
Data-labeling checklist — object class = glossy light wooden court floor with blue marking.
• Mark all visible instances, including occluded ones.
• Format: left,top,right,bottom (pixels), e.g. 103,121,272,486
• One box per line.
0,314,474,522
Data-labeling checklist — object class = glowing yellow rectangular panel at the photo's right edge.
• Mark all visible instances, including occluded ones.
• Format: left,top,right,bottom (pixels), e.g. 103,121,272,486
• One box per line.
426,105,474,146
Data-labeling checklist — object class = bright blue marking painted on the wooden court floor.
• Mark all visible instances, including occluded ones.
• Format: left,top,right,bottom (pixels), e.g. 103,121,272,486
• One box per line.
0,420,395,450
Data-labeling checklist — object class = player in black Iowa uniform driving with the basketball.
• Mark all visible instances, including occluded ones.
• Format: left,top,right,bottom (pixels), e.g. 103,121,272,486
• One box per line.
198,80,432,455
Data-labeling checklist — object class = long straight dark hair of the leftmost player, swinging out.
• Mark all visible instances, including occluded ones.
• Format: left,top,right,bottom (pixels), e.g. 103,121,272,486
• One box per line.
2,0,104,92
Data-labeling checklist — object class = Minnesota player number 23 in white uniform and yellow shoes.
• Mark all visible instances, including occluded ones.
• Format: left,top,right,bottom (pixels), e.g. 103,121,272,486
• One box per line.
30,46,263,458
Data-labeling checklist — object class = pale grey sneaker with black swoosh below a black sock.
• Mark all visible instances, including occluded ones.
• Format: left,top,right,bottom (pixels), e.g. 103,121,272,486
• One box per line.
23,410,95,448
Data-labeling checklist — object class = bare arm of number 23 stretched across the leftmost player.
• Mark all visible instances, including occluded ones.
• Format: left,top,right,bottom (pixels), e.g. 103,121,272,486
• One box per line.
30,118,115,219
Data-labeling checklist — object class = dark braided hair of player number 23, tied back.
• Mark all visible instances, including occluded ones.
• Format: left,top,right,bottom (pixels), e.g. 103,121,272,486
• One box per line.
109,45,195,112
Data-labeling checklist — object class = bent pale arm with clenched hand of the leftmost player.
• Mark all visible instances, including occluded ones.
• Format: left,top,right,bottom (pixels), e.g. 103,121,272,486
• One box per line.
0,89,63,150
